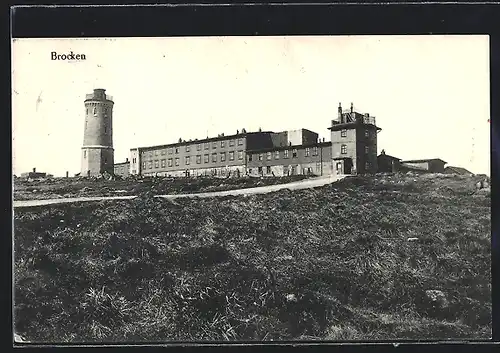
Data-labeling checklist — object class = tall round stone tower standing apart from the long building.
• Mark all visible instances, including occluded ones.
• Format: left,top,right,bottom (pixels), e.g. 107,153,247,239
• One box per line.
80,89,114,176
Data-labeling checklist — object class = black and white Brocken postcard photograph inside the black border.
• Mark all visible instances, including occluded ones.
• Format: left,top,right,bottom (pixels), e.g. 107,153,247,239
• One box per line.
11,35,492,344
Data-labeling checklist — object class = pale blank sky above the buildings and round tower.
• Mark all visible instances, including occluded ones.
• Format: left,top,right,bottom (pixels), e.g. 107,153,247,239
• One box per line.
12,35,490,176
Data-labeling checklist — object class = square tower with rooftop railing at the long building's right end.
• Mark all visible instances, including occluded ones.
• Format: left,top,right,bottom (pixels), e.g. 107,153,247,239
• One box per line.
328,103,382,174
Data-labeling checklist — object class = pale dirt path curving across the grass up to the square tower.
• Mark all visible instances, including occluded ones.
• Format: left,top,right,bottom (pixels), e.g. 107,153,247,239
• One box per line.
14,175,344,208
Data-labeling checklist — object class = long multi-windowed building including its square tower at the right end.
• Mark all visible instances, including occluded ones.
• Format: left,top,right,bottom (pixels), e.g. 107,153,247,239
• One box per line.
115,104,381,177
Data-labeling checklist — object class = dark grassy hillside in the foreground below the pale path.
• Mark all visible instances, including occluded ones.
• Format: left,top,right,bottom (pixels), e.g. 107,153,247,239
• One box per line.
15,175,491,342
